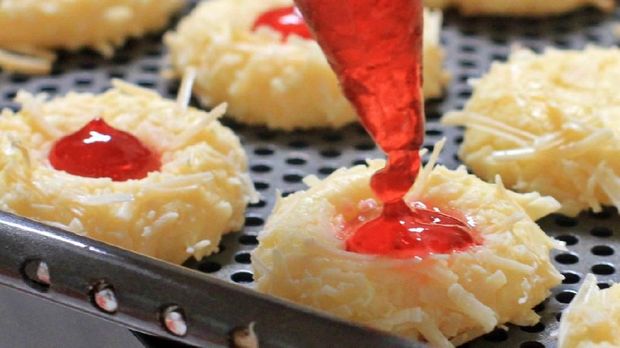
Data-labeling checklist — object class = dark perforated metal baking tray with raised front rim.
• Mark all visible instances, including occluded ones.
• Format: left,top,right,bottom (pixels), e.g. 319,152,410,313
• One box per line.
0,1,620,348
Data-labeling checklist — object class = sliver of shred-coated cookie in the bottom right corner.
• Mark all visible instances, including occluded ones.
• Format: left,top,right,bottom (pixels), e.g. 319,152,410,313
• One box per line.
558,274,620,348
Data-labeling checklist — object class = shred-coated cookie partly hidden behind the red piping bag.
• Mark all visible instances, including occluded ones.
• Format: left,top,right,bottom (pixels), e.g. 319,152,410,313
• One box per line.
165,0,447,130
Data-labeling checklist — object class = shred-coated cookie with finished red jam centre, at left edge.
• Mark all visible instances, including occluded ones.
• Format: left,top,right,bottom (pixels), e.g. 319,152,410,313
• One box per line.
0,81,255,263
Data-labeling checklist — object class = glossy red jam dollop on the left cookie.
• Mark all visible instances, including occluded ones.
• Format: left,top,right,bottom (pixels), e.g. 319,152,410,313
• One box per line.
49,118,161,181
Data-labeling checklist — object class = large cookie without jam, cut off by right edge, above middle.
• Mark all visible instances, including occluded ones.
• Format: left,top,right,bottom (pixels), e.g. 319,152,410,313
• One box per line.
443,47,620,216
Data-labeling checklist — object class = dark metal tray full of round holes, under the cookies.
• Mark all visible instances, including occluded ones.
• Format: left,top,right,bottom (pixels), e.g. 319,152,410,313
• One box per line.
0,1,620,348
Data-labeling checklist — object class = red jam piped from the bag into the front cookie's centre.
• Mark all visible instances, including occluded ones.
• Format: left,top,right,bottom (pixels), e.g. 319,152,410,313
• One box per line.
296,0,478,258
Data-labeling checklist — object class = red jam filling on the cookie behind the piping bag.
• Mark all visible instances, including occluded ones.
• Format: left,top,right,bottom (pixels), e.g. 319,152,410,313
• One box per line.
252,6,312,41
